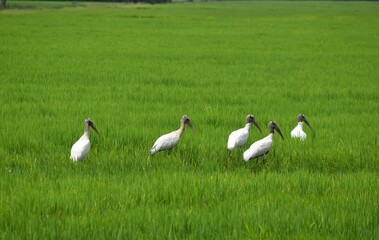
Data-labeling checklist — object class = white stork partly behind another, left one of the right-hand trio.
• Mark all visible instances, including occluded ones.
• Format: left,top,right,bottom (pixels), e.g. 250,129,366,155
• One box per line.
227,114,262,151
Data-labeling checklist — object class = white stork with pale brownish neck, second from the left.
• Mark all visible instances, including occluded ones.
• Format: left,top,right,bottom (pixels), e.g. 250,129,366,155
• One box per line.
150,115,193,155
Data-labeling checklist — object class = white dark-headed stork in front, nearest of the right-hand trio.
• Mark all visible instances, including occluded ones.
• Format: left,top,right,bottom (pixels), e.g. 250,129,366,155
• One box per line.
243,121,284,163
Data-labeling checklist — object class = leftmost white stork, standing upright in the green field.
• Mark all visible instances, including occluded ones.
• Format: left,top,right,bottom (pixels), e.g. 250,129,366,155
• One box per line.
70,118,99,162
